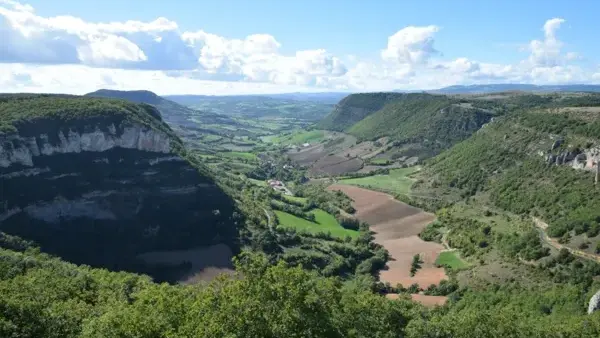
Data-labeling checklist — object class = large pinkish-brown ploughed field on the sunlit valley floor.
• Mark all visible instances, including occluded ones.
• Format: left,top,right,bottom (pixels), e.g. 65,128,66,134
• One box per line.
328,184,447,288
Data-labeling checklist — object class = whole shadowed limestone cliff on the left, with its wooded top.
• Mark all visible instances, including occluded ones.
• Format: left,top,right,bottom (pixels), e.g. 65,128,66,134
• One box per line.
0,95,237,269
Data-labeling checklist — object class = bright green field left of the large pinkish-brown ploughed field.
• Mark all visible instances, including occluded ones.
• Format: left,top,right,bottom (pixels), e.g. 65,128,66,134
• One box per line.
275,209,358,238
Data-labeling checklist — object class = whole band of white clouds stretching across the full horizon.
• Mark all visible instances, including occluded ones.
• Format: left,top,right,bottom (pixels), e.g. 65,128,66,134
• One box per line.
0,0,600,93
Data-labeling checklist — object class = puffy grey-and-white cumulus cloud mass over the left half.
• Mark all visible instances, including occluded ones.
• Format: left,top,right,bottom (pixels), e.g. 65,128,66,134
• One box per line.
0,0,346,85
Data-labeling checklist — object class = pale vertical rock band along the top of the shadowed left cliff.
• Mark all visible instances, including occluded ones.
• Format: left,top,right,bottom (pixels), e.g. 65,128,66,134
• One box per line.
0,125,171,168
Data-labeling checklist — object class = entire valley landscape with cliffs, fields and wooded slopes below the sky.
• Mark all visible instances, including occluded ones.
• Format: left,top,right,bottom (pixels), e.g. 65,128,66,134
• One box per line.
0,90,600,337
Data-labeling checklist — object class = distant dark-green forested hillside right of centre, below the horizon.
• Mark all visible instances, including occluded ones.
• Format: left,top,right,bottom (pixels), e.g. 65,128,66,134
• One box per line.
317,93,502,158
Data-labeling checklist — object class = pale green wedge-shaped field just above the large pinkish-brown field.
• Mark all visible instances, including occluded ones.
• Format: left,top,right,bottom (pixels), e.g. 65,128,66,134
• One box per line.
339,167,420,194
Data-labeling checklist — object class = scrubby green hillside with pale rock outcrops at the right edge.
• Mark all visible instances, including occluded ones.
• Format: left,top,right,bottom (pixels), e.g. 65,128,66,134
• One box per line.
421,94,600,252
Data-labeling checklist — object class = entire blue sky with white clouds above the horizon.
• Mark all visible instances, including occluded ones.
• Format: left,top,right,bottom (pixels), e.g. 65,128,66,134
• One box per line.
0,0,600,95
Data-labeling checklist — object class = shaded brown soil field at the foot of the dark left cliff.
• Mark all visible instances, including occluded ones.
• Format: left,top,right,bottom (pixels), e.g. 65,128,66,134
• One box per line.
138,244,234,284
